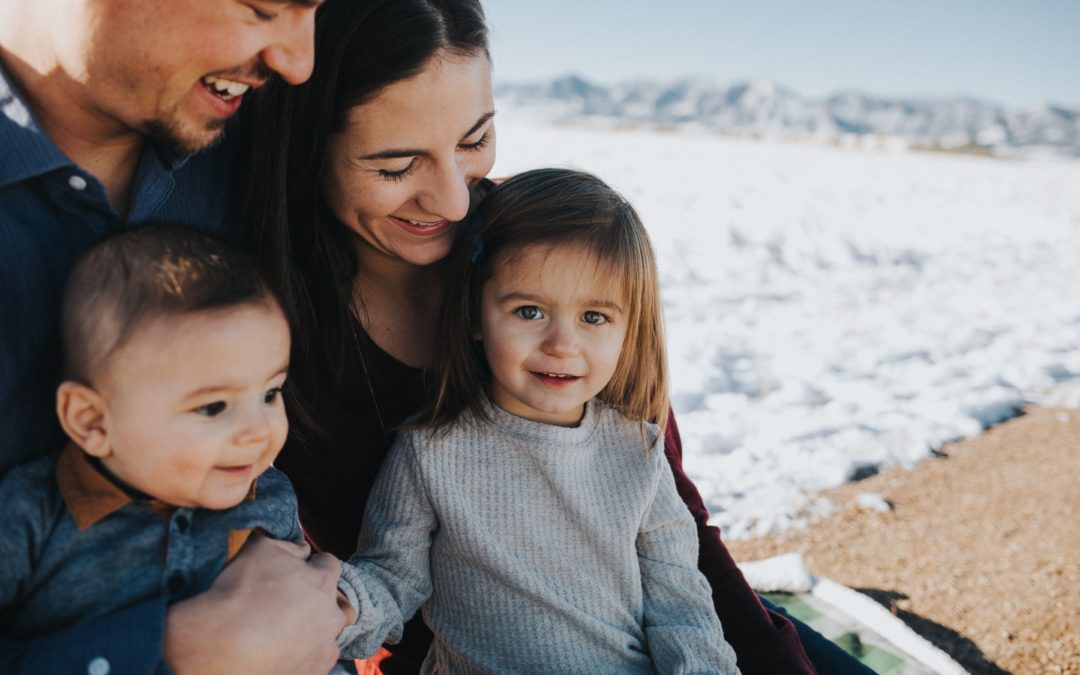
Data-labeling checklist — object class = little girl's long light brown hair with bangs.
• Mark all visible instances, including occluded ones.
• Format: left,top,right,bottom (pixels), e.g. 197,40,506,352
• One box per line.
426,168,669,427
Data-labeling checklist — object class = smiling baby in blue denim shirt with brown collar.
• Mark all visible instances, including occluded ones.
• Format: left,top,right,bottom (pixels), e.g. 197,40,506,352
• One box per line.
0,225,301,639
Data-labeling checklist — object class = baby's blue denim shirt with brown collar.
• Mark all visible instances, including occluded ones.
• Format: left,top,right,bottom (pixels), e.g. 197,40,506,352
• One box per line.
0,445,302,639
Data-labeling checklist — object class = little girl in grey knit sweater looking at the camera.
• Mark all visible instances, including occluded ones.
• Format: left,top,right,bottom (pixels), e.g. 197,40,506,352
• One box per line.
339,170,738,673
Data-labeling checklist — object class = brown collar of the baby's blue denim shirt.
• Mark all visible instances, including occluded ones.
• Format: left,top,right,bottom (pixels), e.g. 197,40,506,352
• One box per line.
56,443,256,530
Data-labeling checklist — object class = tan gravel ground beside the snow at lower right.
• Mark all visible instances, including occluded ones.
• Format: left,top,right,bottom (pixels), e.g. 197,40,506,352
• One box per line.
727,408,1080,675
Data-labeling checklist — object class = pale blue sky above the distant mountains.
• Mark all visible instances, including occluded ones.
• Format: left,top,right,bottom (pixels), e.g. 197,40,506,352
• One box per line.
483,0,1080,108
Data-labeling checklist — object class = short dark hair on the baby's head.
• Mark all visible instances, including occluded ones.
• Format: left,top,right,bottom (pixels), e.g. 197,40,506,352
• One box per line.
60,224,281,384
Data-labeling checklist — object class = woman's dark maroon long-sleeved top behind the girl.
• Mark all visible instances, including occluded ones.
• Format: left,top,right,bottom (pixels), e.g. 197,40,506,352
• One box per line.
275,324,814,675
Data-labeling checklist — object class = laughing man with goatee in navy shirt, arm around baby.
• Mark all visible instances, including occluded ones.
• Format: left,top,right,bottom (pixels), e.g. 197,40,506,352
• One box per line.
0,0,342,675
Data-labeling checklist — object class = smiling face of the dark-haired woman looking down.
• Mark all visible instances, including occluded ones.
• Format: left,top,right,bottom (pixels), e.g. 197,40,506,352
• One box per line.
323,53,495,265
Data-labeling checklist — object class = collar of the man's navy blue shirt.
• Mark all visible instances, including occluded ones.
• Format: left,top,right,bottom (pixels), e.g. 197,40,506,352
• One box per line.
0,64,191,188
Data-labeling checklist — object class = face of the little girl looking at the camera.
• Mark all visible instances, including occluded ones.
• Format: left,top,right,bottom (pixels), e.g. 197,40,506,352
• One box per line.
480,245,627,427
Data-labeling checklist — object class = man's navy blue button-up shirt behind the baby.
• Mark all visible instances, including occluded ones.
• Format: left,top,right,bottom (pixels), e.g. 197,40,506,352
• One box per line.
0,67,243,674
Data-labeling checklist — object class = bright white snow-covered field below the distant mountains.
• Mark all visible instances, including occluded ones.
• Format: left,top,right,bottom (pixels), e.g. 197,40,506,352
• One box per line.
494,113,1080,538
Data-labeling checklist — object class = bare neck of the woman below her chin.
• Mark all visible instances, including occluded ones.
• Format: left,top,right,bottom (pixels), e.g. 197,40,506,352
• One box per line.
352,244,444,368
